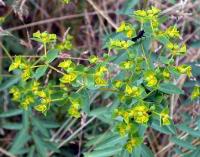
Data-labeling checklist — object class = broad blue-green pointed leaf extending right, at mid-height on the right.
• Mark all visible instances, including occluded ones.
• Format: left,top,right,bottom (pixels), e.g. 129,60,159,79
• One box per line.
158,83,184,94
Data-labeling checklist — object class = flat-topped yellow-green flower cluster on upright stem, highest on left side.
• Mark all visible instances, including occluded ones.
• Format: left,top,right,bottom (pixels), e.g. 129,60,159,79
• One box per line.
33,31,57,44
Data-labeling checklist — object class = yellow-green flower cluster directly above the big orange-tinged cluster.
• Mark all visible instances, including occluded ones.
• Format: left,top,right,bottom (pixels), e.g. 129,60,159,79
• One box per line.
124,85,142,97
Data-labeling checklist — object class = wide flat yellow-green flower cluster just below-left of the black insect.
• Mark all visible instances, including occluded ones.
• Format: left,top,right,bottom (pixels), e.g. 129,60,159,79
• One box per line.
109,39,134,50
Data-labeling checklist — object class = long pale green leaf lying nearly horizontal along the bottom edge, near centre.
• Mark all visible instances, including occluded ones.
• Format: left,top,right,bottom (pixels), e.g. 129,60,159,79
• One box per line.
84,147,122,157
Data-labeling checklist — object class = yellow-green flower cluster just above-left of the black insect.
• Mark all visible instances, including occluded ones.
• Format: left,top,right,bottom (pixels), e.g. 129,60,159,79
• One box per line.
117,22,136,38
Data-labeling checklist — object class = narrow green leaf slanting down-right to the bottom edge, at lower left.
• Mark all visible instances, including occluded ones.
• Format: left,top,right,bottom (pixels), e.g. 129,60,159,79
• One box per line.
32,132,47,157
